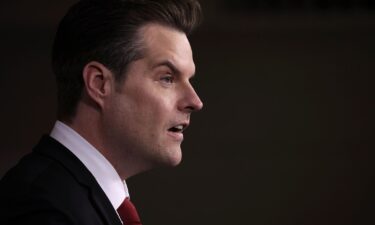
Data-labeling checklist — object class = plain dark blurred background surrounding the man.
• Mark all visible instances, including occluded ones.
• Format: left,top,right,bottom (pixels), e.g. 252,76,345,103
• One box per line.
0,0,375,225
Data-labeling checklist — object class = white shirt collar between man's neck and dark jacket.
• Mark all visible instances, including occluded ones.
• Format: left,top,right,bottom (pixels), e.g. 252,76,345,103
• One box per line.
50,121,129,209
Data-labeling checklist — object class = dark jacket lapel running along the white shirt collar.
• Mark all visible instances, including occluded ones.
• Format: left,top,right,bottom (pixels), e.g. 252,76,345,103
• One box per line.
34,135,122,225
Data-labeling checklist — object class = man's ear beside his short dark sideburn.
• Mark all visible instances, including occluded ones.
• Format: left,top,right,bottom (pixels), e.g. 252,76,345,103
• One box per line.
82,61,114,108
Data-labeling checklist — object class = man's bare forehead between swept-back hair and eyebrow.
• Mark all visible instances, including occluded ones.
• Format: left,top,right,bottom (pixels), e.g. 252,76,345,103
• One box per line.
139,24,195,75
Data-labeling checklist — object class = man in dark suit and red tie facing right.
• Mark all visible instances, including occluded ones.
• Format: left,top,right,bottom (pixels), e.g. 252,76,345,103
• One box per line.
0,0,202,225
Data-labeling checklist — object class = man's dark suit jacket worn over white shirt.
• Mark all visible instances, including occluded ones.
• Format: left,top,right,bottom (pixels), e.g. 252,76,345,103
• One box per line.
0,136,121,225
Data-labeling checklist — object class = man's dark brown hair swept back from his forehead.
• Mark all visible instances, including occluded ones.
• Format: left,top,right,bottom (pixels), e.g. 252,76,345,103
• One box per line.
52,0,201,119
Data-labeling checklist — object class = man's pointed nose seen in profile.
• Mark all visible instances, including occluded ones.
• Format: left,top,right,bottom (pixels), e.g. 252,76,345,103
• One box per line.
179,84,203,113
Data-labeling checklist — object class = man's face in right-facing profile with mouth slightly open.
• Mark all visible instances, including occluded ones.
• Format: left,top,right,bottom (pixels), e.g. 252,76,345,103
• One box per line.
104,24,203,167
